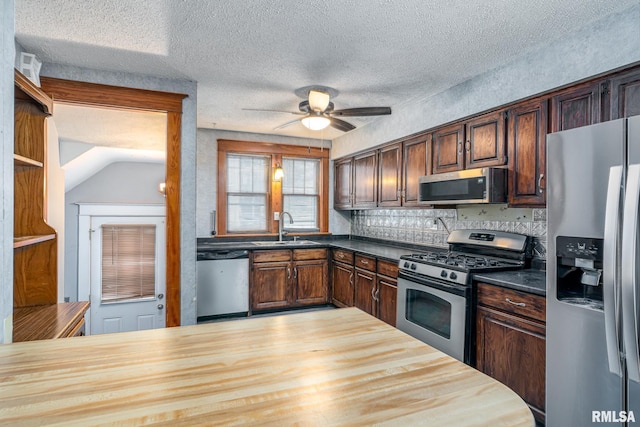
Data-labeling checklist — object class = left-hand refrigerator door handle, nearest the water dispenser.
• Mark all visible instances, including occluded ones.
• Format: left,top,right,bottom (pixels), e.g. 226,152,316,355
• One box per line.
602,166,623,377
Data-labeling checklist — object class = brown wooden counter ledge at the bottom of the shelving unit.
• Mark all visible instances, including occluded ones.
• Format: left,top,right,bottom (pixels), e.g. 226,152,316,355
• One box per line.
13,301,89,342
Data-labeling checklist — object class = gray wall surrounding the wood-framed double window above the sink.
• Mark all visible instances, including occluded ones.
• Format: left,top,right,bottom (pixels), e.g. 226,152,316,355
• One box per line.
196,129,350,237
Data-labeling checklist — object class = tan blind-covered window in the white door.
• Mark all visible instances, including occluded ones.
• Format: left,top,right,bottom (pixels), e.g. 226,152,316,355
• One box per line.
101,224,156,303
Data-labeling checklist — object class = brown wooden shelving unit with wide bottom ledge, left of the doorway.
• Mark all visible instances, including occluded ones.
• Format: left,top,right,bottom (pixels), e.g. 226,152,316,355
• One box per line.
13,70,88,341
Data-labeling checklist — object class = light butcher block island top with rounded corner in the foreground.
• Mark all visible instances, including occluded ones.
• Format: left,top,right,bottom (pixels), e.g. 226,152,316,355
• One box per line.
0,308,534,426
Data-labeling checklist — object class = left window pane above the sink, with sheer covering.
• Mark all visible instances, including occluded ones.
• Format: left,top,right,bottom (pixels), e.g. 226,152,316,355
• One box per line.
227,154,271,233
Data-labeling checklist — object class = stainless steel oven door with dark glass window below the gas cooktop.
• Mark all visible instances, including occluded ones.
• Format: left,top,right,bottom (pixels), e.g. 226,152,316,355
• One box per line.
396,272,471,363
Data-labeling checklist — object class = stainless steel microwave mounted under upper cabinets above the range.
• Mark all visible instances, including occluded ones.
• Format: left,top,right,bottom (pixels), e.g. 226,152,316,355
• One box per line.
419,167,507,205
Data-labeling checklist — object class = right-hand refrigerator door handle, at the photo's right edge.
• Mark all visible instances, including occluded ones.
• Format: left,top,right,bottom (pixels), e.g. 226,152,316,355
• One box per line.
621,164,640,382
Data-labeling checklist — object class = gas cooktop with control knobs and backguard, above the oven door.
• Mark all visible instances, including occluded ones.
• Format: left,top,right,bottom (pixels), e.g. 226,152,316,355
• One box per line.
399,230,530,285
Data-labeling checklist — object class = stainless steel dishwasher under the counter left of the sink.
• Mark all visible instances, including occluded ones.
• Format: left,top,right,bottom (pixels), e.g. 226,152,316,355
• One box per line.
197,249,249,321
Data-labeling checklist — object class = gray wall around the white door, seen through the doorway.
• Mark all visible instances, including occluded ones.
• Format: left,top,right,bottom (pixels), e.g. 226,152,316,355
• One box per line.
64,162,166,301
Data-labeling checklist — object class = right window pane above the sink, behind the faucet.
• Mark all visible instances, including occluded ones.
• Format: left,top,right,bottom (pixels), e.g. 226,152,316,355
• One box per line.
282,158,320,231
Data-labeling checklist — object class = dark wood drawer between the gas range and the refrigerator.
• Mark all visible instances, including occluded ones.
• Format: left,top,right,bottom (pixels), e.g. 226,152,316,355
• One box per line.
478,283,546,322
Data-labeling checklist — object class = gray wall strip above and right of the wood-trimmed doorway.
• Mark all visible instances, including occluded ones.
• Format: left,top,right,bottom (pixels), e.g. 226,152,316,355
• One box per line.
40,63,197,325
